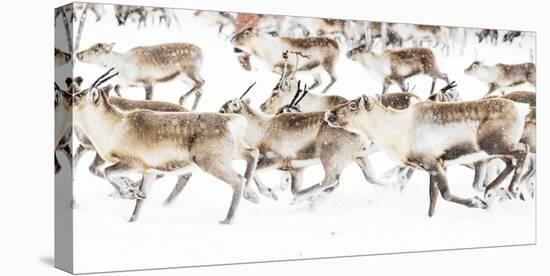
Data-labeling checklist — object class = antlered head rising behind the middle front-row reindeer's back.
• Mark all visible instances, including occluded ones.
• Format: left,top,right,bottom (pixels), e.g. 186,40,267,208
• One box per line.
260,50,309,114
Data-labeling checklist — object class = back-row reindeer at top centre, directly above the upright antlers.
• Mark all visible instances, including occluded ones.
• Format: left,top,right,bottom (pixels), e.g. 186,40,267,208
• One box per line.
231,27,339,93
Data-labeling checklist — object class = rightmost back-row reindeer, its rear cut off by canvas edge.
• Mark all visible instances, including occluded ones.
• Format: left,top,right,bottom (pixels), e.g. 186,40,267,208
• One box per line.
464,60,536,96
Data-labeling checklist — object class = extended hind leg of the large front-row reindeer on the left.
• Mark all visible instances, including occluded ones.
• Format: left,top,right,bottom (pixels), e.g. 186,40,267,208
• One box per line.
193,153,246,224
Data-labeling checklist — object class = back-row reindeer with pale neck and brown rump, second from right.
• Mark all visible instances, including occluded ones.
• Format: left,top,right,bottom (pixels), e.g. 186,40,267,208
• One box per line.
347,44,449,94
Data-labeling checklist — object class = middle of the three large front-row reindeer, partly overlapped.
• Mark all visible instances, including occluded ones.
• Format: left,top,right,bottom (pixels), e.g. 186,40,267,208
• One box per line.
219,83,390,199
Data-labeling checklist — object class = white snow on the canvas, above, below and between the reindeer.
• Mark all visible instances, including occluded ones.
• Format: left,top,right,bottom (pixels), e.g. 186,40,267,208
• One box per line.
54,5,536,273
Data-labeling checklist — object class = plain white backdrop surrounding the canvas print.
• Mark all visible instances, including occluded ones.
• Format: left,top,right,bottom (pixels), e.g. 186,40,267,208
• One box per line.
0,1,548,275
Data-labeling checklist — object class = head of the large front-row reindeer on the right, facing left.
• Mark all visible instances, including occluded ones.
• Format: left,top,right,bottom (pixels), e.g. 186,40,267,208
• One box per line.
324,95,387,129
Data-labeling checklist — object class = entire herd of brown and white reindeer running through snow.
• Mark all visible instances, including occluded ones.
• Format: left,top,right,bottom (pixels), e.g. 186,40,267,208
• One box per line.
55,6,536,224
